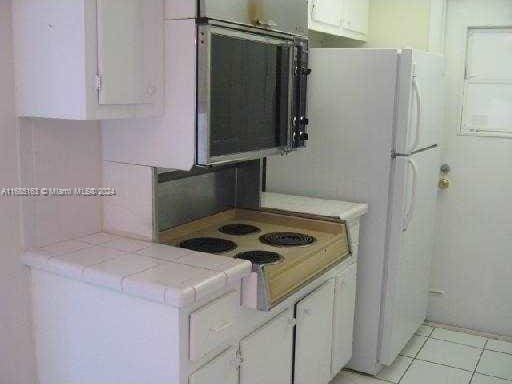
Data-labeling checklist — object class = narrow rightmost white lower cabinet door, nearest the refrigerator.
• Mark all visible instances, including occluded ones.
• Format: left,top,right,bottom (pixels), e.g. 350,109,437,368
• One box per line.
332,264,357,377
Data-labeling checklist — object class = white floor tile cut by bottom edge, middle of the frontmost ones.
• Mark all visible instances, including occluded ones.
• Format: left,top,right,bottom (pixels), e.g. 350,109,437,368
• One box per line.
400,360,471,384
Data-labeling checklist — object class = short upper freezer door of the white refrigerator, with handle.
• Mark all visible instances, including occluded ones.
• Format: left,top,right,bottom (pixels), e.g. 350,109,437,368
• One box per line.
395,49,444,154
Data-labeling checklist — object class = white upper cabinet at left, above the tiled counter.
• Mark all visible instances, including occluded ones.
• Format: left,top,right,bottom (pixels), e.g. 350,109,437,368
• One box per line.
13,0,164,120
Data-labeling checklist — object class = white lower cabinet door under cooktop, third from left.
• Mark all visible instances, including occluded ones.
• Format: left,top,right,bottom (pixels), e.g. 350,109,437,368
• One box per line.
295,279,334,384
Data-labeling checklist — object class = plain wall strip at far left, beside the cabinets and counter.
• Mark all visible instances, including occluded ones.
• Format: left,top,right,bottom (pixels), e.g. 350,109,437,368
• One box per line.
0,0,36,384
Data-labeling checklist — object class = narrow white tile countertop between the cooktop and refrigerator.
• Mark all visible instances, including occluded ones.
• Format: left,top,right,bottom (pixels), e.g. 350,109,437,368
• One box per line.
261,192,368,220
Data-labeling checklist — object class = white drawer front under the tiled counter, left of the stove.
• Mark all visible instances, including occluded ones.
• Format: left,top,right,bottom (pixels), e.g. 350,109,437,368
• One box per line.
190,292,240,361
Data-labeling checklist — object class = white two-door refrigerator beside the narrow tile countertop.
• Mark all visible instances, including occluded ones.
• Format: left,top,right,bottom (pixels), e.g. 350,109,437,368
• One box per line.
266,48,444,374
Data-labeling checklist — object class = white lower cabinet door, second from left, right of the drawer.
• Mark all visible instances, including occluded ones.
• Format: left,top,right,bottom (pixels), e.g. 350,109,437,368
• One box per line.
239,309,294,384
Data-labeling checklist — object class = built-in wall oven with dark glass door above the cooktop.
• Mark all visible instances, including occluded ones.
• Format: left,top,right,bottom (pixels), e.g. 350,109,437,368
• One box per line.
197,1,310,165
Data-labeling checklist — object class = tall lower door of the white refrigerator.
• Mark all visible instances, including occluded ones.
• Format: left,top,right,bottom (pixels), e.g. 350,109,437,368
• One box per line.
379,148,441,365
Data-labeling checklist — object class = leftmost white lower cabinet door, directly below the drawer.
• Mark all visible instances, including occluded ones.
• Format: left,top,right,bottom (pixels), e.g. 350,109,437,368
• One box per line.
189,348,238,384
